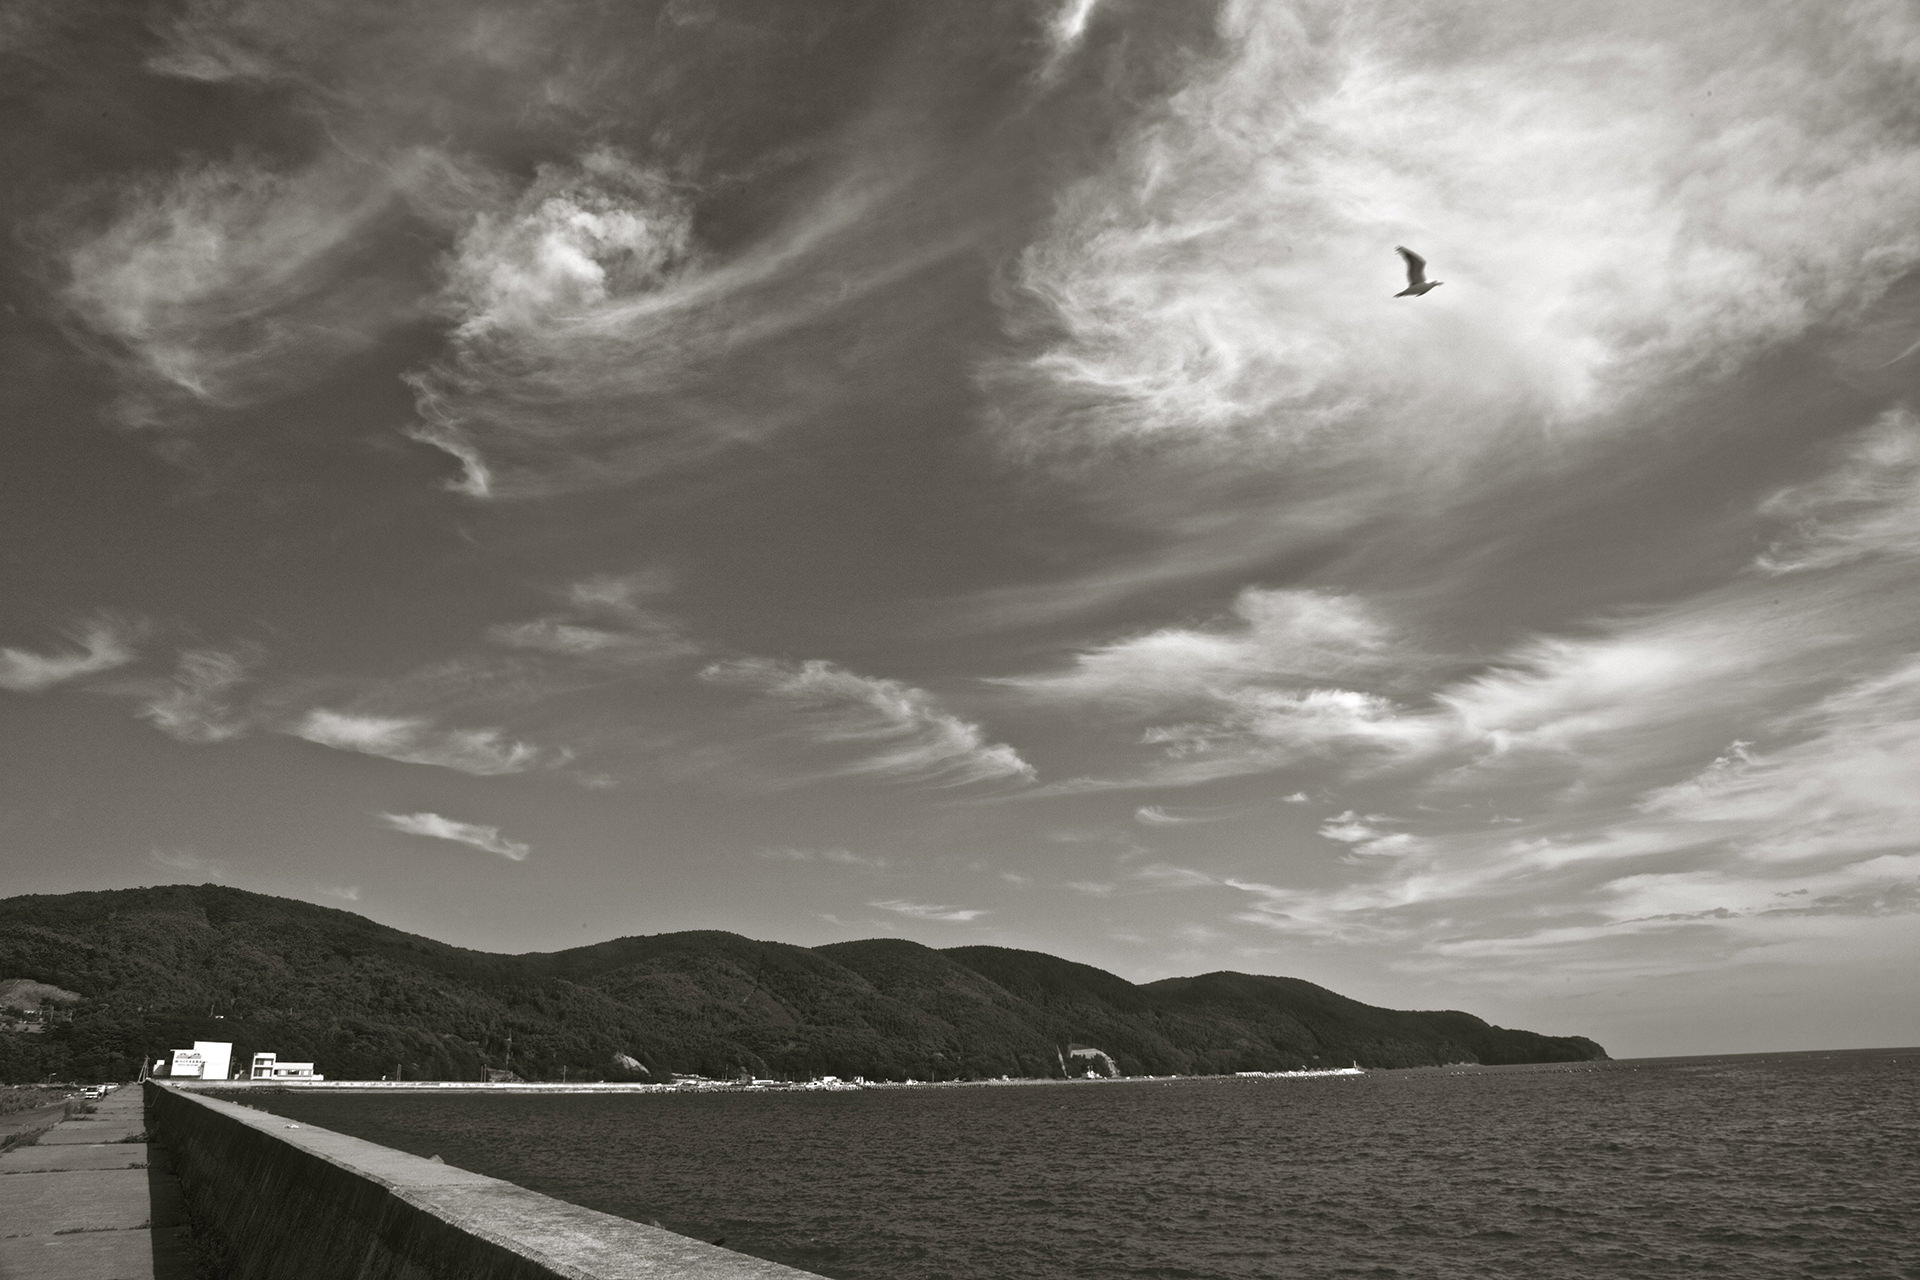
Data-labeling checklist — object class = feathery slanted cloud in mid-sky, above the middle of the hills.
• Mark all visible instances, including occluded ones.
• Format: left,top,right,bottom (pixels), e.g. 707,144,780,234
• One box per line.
701,658,1033,787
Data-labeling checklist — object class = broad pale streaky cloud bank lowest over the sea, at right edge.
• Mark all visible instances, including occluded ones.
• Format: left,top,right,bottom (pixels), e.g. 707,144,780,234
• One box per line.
1198,640,1920,975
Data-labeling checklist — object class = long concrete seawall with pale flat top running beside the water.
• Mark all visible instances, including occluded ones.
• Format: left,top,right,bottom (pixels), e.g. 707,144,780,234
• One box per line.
146,1082,818,1280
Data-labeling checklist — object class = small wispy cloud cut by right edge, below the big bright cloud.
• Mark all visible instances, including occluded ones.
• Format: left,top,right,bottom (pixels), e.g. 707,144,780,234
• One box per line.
1757,405,1920,574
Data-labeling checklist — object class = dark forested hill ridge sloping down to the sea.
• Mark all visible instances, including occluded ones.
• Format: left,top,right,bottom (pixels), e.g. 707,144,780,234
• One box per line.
0,885,1605,1080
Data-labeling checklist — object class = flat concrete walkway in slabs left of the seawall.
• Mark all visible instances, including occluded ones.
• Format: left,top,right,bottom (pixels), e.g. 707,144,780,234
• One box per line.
0,1084,194,1280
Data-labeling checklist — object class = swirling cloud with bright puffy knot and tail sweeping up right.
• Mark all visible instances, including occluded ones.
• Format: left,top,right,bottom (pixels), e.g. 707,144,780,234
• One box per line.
407,148,956,497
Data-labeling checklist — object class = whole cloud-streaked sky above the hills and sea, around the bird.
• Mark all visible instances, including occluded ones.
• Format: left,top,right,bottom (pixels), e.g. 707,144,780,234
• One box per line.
0,0,1920,1055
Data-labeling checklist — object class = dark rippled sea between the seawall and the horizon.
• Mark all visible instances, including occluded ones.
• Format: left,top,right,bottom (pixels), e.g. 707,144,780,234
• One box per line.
248,1050,1920,1280
